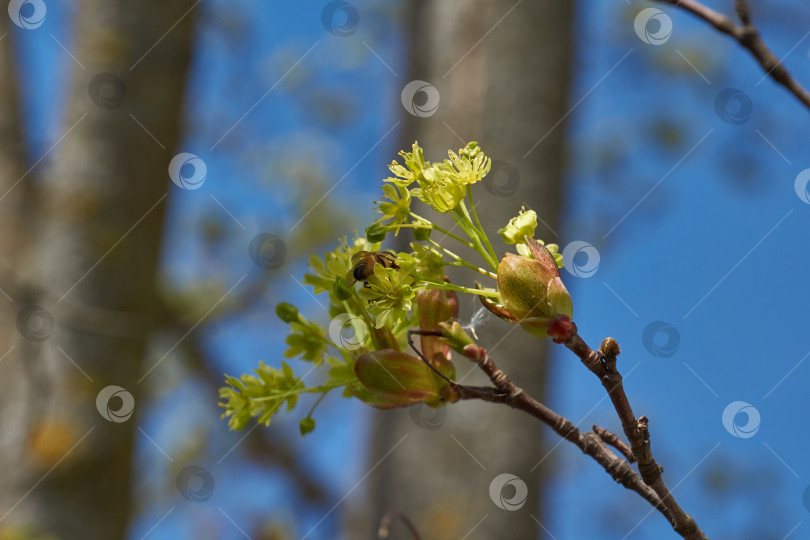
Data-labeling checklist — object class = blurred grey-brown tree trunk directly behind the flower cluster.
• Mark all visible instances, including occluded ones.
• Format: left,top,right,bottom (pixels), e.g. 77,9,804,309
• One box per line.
352,0,573,539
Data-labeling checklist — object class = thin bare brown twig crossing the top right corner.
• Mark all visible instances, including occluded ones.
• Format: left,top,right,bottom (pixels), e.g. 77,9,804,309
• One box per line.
657,0,810,109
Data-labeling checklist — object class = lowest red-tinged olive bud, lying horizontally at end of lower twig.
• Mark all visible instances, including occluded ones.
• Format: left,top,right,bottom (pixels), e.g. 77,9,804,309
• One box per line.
354,349,452,409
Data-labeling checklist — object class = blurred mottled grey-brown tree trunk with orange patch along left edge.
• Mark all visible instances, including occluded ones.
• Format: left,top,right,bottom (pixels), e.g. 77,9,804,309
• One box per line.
0,0,194,540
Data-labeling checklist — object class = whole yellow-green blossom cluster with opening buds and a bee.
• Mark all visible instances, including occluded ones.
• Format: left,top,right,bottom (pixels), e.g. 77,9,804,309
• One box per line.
220,142,572,435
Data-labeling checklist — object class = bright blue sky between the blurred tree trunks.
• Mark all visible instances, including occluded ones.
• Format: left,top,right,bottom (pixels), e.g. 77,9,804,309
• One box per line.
17,0,810,539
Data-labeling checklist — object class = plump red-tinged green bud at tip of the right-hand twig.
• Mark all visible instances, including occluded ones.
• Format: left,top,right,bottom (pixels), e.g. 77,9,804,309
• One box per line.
485,238,573,337
